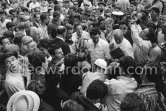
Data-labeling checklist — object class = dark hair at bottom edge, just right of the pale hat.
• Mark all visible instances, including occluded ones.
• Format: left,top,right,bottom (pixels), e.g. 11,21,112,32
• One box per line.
62,100,84,111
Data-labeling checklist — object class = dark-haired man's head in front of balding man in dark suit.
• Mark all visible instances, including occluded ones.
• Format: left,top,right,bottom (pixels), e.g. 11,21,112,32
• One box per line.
48,45,64,60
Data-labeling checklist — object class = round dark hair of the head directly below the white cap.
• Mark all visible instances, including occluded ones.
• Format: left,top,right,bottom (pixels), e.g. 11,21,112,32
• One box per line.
86,80,108,100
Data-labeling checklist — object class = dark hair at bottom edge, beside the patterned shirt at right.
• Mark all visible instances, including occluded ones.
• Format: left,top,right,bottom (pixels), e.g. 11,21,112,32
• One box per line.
120,93,146,111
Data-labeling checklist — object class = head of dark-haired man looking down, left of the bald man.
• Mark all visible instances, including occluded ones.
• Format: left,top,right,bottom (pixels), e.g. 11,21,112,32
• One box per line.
90,27,100,44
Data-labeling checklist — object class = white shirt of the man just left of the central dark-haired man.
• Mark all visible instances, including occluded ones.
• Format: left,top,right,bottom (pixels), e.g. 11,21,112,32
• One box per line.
71,31,90,53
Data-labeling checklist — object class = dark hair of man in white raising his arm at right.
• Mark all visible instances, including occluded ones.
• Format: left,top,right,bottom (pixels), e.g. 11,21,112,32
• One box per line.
146,27,157,43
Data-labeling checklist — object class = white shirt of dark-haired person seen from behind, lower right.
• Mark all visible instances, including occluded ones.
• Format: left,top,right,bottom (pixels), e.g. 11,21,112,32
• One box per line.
105,76,137,111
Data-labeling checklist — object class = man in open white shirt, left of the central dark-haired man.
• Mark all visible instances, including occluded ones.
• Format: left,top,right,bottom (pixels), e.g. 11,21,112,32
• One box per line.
71,24,90,53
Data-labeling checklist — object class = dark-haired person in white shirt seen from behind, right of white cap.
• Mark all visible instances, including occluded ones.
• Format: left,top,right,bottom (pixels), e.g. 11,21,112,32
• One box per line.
105,56,137,111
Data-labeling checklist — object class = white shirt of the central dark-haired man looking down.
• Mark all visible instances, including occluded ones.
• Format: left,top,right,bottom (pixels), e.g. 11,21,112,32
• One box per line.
88,38,111,64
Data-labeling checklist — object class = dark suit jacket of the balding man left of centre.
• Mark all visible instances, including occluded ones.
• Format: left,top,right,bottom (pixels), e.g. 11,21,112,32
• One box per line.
53,38,70,55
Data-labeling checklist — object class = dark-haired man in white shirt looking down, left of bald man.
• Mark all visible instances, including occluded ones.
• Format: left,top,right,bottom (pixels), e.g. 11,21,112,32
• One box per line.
87,28,111,64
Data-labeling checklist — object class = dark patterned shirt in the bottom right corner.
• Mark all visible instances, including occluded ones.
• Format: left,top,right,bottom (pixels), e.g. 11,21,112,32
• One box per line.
134,83,158,111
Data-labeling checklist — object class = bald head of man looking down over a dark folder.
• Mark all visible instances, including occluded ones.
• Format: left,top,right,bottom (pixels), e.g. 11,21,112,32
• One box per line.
113,29,124,44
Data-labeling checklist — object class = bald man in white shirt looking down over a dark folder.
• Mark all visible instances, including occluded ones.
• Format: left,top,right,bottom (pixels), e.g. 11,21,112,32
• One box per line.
113,29,134,58
